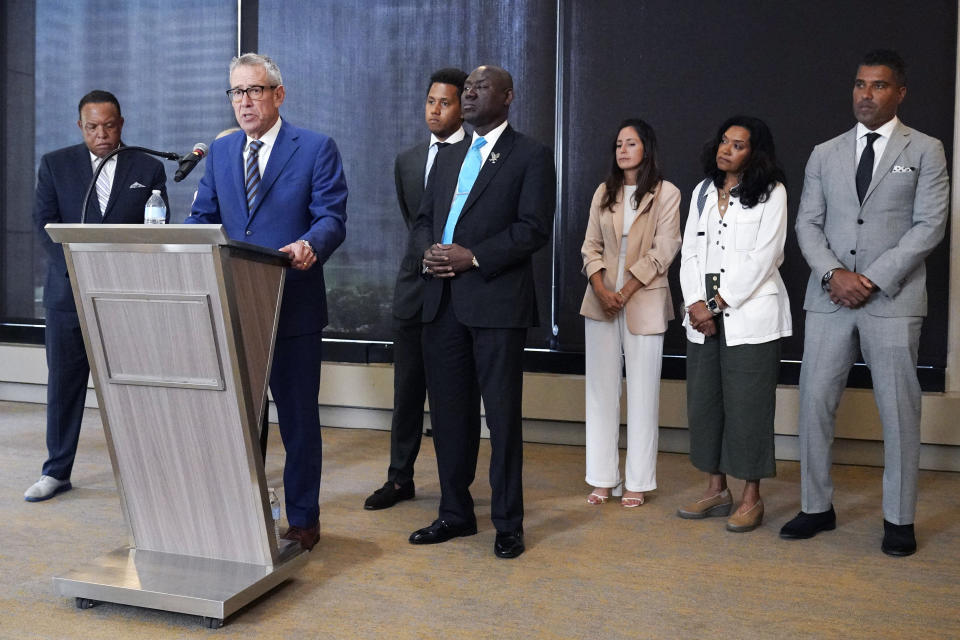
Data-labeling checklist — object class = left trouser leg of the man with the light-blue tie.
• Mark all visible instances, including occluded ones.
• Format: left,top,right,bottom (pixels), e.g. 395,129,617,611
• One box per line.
423,285,480,525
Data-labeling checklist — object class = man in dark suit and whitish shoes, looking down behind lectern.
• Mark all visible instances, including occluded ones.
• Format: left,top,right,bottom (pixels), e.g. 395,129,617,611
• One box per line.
24,91,169,502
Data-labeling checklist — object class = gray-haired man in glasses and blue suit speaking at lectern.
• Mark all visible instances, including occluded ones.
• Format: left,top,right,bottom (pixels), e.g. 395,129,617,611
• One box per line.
186,53,347,550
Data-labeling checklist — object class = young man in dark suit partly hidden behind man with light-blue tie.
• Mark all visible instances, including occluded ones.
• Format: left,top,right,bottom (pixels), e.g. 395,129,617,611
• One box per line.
363,68,467,509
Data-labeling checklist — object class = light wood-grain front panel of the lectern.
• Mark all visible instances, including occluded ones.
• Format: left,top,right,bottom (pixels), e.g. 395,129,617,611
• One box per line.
71,245,282,565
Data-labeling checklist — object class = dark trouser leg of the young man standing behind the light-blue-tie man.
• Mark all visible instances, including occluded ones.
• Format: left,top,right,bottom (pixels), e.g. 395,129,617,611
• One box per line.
387,314,427,485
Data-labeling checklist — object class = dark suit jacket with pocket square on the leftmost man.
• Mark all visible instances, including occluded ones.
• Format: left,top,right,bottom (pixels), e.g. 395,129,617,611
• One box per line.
33,144,170,311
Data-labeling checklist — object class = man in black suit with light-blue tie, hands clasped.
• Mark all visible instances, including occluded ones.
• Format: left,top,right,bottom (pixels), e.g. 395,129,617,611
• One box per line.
410,66,556,558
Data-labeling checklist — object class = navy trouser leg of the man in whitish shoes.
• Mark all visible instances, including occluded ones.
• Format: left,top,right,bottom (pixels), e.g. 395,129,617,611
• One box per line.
42,309,90,480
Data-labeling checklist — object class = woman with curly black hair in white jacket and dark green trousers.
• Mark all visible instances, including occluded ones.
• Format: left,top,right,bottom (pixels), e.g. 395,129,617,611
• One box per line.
677,116,792,532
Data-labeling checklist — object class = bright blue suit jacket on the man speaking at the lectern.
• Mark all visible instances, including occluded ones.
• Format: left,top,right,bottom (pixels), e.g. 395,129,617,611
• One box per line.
186,121,347,337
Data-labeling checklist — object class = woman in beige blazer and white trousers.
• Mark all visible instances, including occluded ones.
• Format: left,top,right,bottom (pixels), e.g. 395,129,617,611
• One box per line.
580,119,680,507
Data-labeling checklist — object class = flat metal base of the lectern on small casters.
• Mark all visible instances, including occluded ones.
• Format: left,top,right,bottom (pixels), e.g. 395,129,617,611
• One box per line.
53,540,307,627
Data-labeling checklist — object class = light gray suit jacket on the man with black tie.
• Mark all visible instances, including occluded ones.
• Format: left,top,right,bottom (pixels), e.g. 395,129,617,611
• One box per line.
797,123,950,317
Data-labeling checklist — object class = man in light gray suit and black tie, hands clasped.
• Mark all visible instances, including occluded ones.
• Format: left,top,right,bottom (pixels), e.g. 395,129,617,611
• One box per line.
780,50,949,556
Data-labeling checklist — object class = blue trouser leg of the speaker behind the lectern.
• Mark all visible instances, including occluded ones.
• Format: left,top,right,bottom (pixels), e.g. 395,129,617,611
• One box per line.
270,333,323,528
